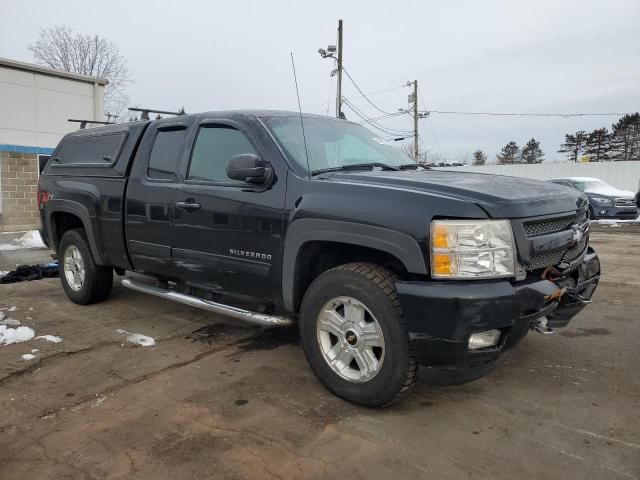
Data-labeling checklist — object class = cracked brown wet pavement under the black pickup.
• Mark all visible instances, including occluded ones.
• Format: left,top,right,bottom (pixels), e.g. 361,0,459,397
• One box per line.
0,231,640,480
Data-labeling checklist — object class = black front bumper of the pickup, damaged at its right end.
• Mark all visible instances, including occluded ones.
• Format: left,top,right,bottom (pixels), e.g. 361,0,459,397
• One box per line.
396,247,600,366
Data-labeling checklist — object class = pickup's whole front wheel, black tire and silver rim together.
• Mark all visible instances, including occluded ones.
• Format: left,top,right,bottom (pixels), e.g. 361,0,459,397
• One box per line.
300,263,418,407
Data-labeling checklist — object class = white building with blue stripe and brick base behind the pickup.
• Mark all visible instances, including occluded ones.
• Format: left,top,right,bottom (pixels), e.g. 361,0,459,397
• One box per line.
0,58,107,232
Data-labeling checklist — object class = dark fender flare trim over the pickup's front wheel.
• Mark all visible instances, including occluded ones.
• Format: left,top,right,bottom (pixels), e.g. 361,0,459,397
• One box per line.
282,218,428,312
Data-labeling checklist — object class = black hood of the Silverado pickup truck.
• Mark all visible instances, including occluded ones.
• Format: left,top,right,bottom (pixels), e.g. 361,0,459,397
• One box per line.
323,170,587,218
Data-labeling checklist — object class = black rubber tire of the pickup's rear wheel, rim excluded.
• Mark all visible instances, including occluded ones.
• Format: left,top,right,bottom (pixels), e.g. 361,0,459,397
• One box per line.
58,229,113,305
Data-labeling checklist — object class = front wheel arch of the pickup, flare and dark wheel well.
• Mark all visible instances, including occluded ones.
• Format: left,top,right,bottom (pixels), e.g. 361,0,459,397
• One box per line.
282,219,427,312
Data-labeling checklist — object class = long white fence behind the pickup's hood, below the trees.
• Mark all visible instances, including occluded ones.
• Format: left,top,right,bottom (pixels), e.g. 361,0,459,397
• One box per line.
446,162,640,192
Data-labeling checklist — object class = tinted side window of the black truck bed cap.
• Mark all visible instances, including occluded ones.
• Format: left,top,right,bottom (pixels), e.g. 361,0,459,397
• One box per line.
54,132,127,166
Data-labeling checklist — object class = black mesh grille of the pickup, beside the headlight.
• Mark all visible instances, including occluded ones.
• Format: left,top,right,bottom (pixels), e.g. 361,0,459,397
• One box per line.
523,212,589,271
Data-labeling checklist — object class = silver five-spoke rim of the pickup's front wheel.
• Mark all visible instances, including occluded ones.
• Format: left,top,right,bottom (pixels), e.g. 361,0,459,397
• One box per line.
316,297,385,383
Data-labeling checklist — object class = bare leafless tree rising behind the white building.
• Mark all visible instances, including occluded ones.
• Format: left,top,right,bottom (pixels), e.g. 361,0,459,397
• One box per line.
28,25,131,119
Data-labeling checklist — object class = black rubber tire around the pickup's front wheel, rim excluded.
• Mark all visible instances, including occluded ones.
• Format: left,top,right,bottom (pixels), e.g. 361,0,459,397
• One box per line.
299,263,418,407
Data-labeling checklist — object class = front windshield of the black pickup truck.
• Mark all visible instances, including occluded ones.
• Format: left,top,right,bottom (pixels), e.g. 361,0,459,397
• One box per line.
262,116,415,172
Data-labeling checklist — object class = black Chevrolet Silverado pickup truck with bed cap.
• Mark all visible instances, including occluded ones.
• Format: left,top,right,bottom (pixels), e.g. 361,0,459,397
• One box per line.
38,111,600,406
